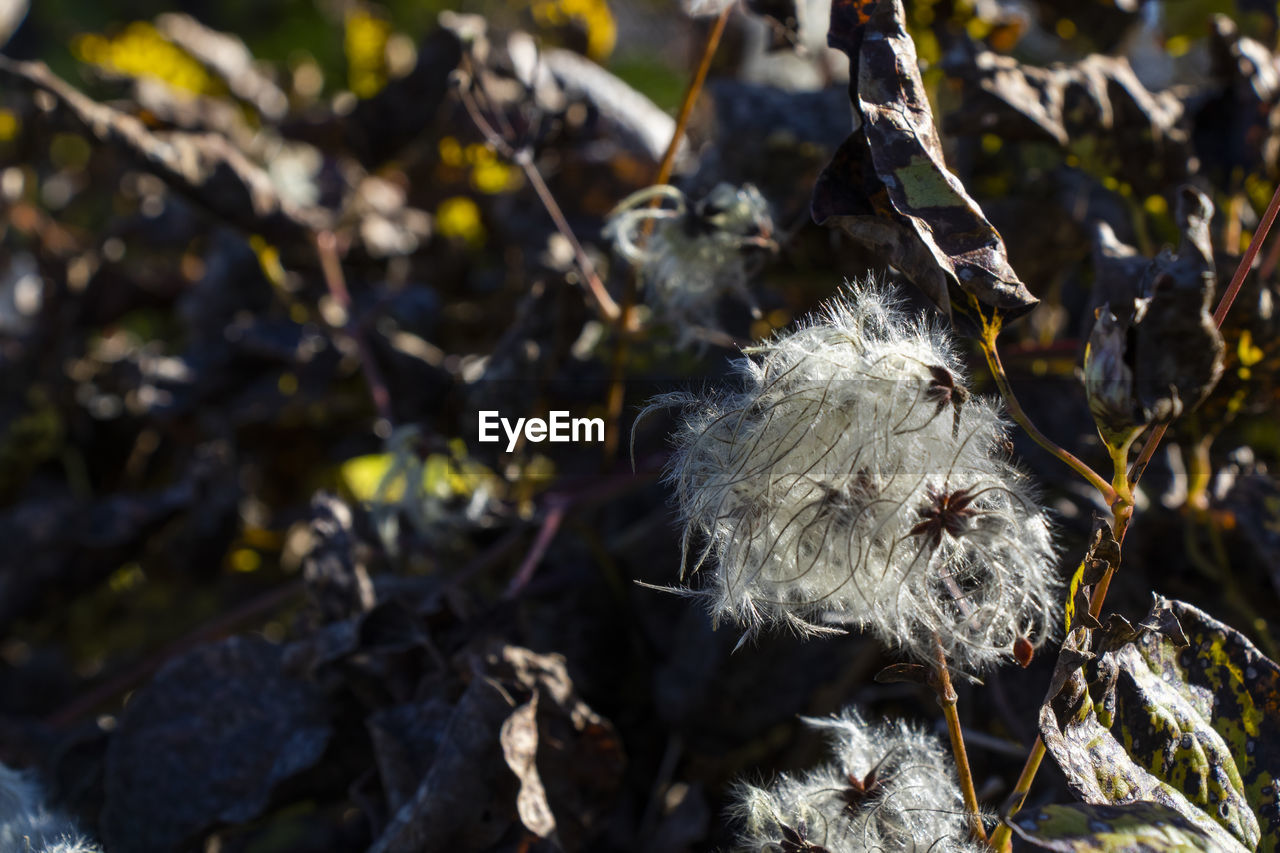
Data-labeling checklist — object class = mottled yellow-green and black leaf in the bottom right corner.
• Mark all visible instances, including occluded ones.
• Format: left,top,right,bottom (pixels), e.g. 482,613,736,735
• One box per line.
1041,598,1280,850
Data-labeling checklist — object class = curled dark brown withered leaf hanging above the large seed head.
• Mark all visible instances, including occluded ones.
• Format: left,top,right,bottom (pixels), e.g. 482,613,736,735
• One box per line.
813,0,1038,319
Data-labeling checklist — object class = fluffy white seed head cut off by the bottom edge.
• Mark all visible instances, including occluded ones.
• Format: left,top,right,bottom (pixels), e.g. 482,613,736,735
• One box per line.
735,710,984,853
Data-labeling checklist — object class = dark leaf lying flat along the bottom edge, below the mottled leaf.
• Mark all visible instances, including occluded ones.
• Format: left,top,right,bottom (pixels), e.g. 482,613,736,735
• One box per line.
1009,803,1213,853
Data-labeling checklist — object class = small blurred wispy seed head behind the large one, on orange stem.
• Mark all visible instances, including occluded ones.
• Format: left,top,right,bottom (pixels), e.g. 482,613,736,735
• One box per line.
605,183,774,343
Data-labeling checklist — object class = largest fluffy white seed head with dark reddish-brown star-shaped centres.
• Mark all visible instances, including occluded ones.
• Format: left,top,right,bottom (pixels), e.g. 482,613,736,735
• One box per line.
652,281,1057,670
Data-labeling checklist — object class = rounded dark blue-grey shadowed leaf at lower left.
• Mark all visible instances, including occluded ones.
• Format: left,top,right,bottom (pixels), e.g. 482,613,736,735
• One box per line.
102,637,332,853
